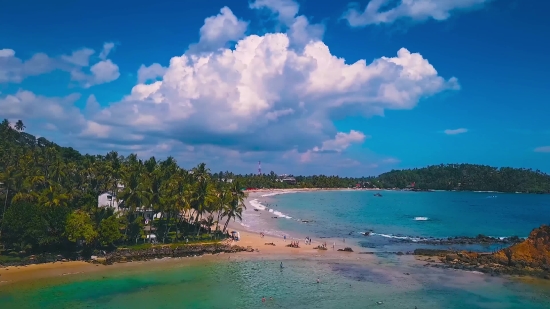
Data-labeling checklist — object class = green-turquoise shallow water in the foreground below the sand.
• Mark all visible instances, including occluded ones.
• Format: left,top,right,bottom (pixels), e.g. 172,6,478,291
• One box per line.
0,257,550,309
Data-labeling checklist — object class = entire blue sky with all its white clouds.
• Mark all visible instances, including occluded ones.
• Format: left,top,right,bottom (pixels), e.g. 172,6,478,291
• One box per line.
0,0,550,176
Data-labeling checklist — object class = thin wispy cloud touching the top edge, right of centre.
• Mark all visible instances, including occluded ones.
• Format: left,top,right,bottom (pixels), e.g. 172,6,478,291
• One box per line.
342,0,492,27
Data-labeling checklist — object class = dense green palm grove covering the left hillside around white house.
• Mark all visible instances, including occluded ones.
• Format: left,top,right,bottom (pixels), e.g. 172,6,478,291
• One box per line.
0,120,246,261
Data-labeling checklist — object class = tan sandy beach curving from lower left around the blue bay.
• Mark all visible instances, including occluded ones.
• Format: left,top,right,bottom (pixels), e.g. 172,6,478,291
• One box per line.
0,189,372,286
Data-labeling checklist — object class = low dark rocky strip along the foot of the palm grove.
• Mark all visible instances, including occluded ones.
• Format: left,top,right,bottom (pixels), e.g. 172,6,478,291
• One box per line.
101,244,251,265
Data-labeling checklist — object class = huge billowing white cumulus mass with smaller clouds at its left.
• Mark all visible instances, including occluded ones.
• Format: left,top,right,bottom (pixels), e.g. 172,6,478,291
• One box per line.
0,0,460,172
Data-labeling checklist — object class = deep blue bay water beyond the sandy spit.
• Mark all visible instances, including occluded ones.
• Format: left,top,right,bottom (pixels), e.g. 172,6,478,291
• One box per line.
258,190,550,251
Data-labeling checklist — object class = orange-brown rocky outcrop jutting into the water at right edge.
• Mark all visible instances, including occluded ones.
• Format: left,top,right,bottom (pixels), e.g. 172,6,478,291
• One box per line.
415,225,550,279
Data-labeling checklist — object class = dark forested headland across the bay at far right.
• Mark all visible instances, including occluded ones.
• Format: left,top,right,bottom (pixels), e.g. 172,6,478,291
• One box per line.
377,164,550,193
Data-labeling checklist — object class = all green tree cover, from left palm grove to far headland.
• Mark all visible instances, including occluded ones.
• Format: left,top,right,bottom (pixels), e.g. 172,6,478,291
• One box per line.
0,120,550,260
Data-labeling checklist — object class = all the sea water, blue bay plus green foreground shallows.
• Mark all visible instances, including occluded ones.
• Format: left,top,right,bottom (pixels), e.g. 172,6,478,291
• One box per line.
0,191,550,309
